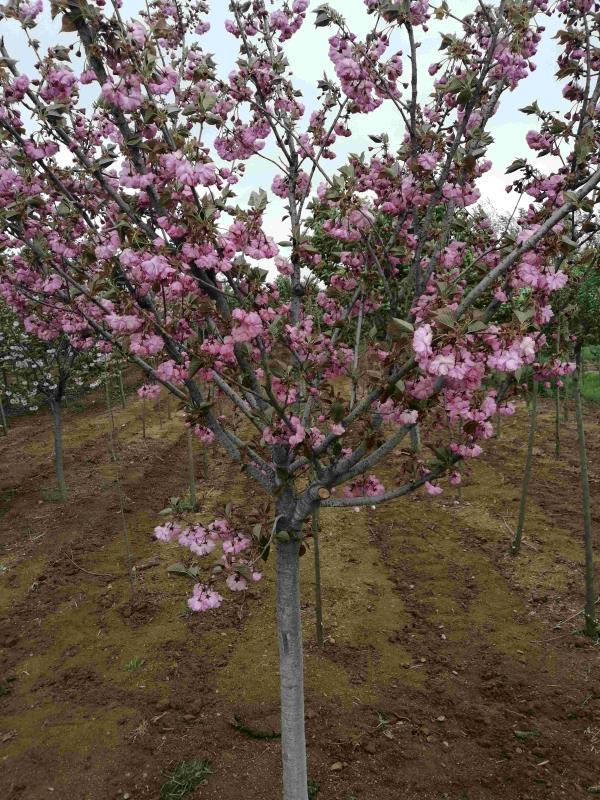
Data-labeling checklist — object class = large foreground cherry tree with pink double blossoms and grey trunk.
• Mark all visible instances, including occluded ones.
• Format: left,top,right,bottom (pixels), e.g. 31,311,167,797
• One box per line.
0,0,600,800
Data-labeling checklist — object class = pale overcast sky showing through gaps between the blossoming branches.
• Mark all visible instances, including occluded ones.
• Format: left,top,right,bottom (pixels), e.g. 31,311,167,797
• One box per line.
5,0,564,239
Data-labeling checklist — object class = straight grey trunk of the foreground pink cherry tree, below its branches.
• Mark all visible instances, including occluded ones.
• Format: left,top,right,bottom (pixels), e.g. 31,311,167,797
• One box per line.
277,540,308,800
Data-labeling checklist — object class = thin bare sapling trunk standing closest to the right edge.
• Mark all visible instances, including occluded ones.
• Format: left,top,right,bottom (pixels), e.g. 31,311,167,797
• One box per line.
575,348,598,638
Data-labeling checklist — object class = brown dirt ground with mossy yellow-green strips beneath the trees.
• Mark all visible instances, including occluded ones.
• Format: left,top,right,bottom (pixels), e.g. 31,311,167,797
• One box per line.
0,388,600,800
